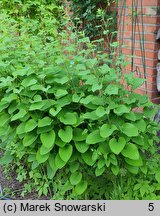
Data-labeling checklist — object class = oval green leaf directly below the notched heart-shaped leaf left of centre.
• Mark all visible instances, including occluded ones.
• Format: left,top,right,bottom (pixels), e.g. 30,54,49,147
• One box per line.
59,144,73,162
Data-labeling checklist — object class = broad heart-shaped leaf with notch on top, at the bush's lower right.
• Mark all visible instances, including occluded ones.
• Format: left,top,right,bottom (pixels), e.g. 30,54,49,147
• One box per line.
109,137,126,155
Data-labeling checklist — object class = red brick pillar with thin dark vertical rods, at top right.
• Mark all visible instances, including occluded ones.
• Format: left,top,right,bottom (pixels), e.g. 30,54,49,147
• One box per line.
118,0,160,103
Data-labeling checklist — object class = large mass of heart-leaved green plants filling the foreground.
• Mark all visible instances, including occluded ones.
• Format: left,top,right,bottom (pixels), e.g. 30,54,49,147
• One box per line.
0,1,160,199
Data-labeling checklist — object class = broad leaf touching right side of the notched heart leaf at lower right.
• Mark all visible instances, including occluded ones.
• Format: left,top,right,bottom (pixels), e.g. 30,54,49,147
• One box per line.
121,143,140,160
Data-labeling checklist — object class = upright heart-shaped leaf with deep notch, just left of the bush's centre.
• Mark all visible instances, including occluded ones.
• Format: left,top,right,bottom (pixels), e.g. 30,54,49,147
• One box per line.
58,126,73,143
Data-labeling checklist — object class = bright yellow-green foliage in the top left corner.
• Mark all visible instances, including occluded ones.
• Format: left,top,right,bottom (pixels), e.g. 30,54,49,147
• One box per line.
0,0,65,36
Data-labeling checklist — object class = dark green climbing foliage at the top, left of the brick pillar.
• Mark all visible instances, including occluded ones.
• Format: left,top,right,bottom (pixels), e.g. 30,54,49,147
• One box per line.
68,0,116,39
